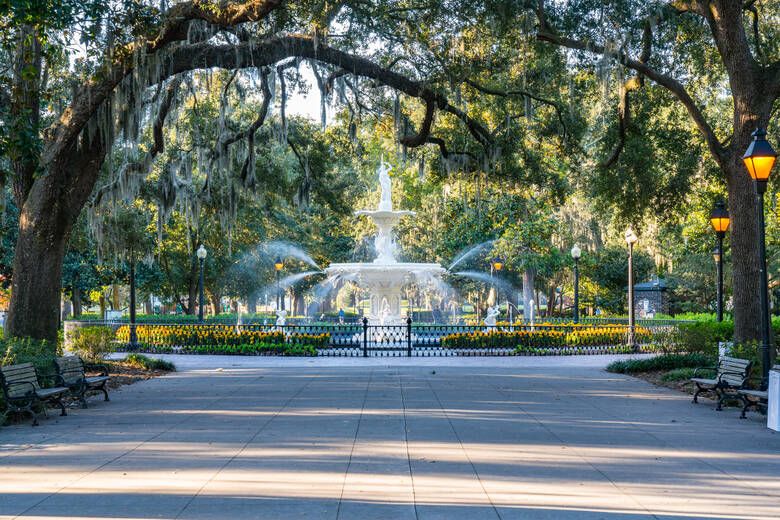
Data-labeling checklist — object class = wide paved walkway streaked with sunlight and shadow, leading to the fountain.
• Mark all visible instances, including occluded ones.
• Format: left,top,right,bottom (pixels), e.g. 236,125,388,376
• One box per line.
0,356,780,520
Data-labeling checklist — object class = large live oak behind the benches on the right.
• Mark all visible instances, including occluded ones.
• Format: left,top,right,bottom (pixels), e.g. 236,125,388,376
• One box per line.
525,0,780,341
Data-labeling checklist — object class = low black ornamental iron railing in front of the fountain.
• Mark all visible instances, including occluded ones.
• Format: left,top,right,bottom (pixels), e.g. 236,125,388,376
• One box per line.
82,320,681,356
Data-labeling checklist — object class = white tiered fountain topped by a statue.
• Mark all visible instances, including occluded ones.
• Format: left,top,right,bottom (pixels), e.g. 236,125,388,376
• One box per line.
325,159,445,325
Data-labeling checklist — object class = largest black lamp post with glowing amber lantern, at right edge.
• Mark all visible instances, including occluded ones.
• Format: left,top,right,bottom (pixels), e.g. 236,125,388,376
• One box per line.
742,128,777,378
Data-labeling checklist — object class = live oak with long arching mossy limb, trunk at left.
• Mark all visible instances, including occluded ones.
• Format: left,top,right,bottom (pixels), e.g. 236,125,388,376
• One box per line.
0,0,512,339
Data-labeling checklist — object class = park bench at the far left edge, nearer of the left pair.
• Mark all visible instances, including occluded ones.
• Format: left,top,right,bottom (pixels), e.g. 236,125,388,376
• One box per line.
0,363,68,426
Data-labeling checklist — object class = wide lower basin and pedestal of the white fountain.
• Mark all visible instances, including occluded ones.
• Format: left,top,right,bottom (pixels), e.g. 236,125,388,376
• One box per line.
325,262,446,325
